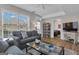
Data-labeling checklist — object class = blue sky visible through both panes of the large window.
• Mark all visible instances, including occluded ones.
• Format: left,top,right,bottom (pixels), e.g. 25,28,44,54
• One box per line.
3,12,28,23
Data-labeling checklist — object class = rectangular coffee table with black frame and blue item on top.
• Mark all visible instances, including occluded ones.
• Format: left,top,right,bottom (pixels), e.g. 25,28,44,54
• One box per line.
26,42,63,55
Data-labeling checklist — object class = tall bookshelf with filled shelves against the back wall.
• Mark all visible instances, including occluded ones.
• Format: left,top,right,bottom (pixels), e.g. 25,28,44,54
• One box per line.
43,23,51,38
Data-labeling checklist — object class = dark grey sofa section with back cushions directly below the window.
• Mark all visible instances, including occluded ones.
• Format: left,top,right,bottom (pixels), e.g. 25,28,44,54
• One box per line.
12,30,41,49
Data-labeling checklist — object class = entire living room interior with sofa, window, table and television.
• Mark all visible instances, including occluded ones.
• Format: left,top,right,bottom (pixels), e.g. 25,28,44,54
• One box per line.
0,4,79,55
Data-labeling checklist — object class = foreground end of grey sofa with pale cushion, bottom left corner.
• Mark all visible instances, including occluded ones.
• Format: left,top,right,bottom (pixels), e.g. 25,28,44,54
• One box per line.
0,40,26,55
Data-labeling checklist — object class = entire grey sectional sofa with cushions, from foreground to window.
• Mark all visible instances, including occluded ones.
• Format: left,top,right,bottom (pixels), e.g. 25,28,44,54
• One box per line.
0,31,41,55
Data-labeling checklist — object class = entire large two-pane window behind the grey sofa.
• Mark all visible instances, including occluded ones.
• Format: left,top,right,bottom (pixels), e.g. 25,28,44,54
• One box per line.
0,11,30,38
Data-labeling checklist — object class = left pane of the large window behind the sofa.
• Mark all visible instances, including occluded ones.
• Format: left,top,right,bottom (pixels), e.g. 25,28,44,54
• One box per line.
3,12,18,37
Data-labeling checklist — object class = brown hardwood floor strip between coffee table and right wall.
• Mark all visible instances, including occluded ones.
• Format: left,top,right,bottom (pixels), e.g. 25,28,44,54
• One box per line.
42,38,79,54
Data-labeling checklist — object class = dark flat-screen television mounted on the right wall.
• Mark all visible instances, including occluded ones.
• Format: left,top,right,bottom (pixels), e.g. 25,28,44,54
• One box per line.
63,22,78,31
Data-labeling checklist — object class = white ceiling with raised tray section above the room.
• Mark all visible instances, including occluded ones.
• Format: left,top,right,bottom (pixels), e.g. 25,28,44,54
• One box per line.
14,4,79,18
